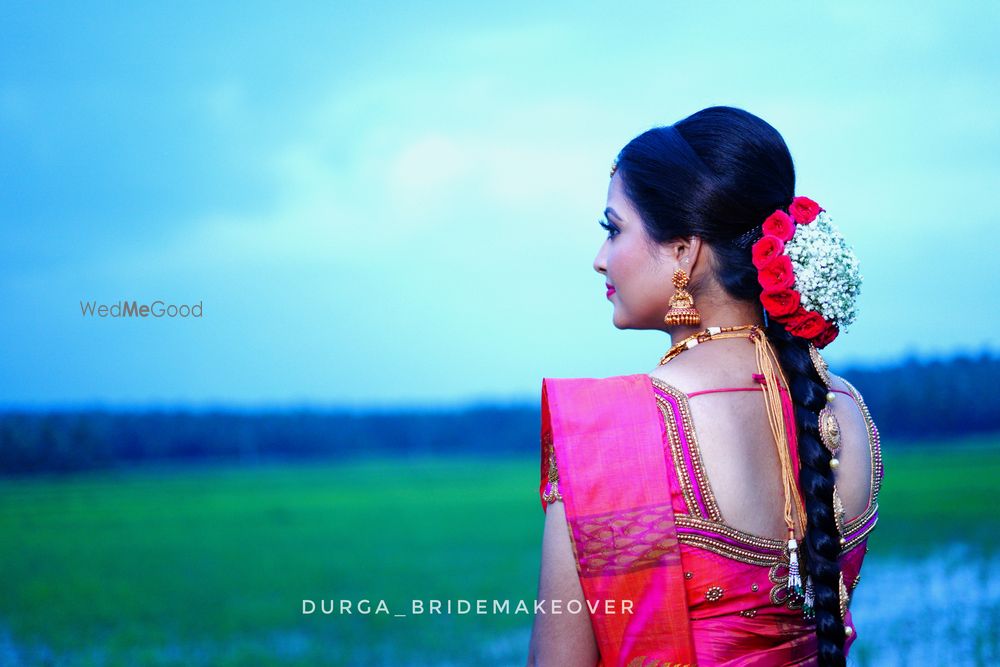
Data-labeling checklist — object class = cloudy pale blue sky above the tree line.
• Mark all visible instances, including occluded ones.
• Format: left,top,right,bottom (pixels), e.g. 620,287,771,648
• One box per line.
0,2,1000,406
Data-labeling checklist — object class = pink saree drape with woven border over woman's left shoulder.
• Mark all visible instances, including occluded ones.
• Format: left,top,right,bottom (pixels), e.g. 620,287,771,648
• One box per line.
542,375,694,667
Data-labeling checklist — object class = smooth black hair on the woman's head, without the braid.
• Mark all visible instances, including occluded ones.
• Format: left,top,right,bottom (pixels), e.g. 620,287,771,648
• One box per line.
617,107,795,302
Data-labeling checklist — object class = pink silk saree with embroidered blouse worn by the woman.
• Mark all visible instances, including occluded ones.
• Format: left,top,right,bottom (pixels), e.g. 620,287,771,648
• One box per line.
539,374,882,667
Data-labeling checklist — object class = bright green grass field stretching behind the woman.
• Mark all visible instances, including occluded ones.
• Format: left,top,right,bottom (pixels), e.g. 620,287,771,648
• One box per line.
0,440,1000,666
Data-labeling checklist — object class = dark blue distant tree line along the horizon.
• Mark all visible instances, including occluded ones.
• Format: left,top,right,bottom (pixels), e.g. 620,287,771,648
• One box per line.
0,352,1000,475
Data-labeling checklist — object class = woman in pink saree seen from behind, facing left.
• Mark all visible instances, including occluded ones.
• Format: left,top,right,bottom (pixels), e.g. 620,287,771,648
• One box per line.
528,107,882,667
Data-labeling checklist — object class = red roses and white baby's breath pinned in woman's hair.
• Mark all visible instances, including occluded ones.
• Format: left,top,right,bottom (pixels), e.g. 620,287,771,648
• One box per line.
751,197,861,348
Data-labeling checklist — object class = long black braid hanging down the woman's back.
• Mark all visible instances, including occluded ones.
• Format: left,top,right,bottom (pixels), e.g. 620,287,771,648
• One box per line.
766,320,845,667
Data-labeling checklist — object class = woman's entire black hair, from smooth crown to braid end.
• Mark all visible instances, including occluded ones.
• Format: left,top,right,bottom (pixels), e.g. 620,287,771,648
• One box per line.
617,106,845,667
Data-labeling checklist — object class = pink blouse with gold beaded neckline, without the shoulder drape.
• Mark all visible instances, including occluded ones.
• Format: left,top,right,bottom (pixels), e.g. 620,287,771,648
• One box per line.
542,377,883,664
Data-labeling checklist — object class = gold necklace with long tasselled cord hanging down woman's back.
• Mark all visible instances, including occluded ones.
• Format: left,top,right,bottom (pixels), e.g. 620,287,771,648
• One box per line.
660,324,806,608
